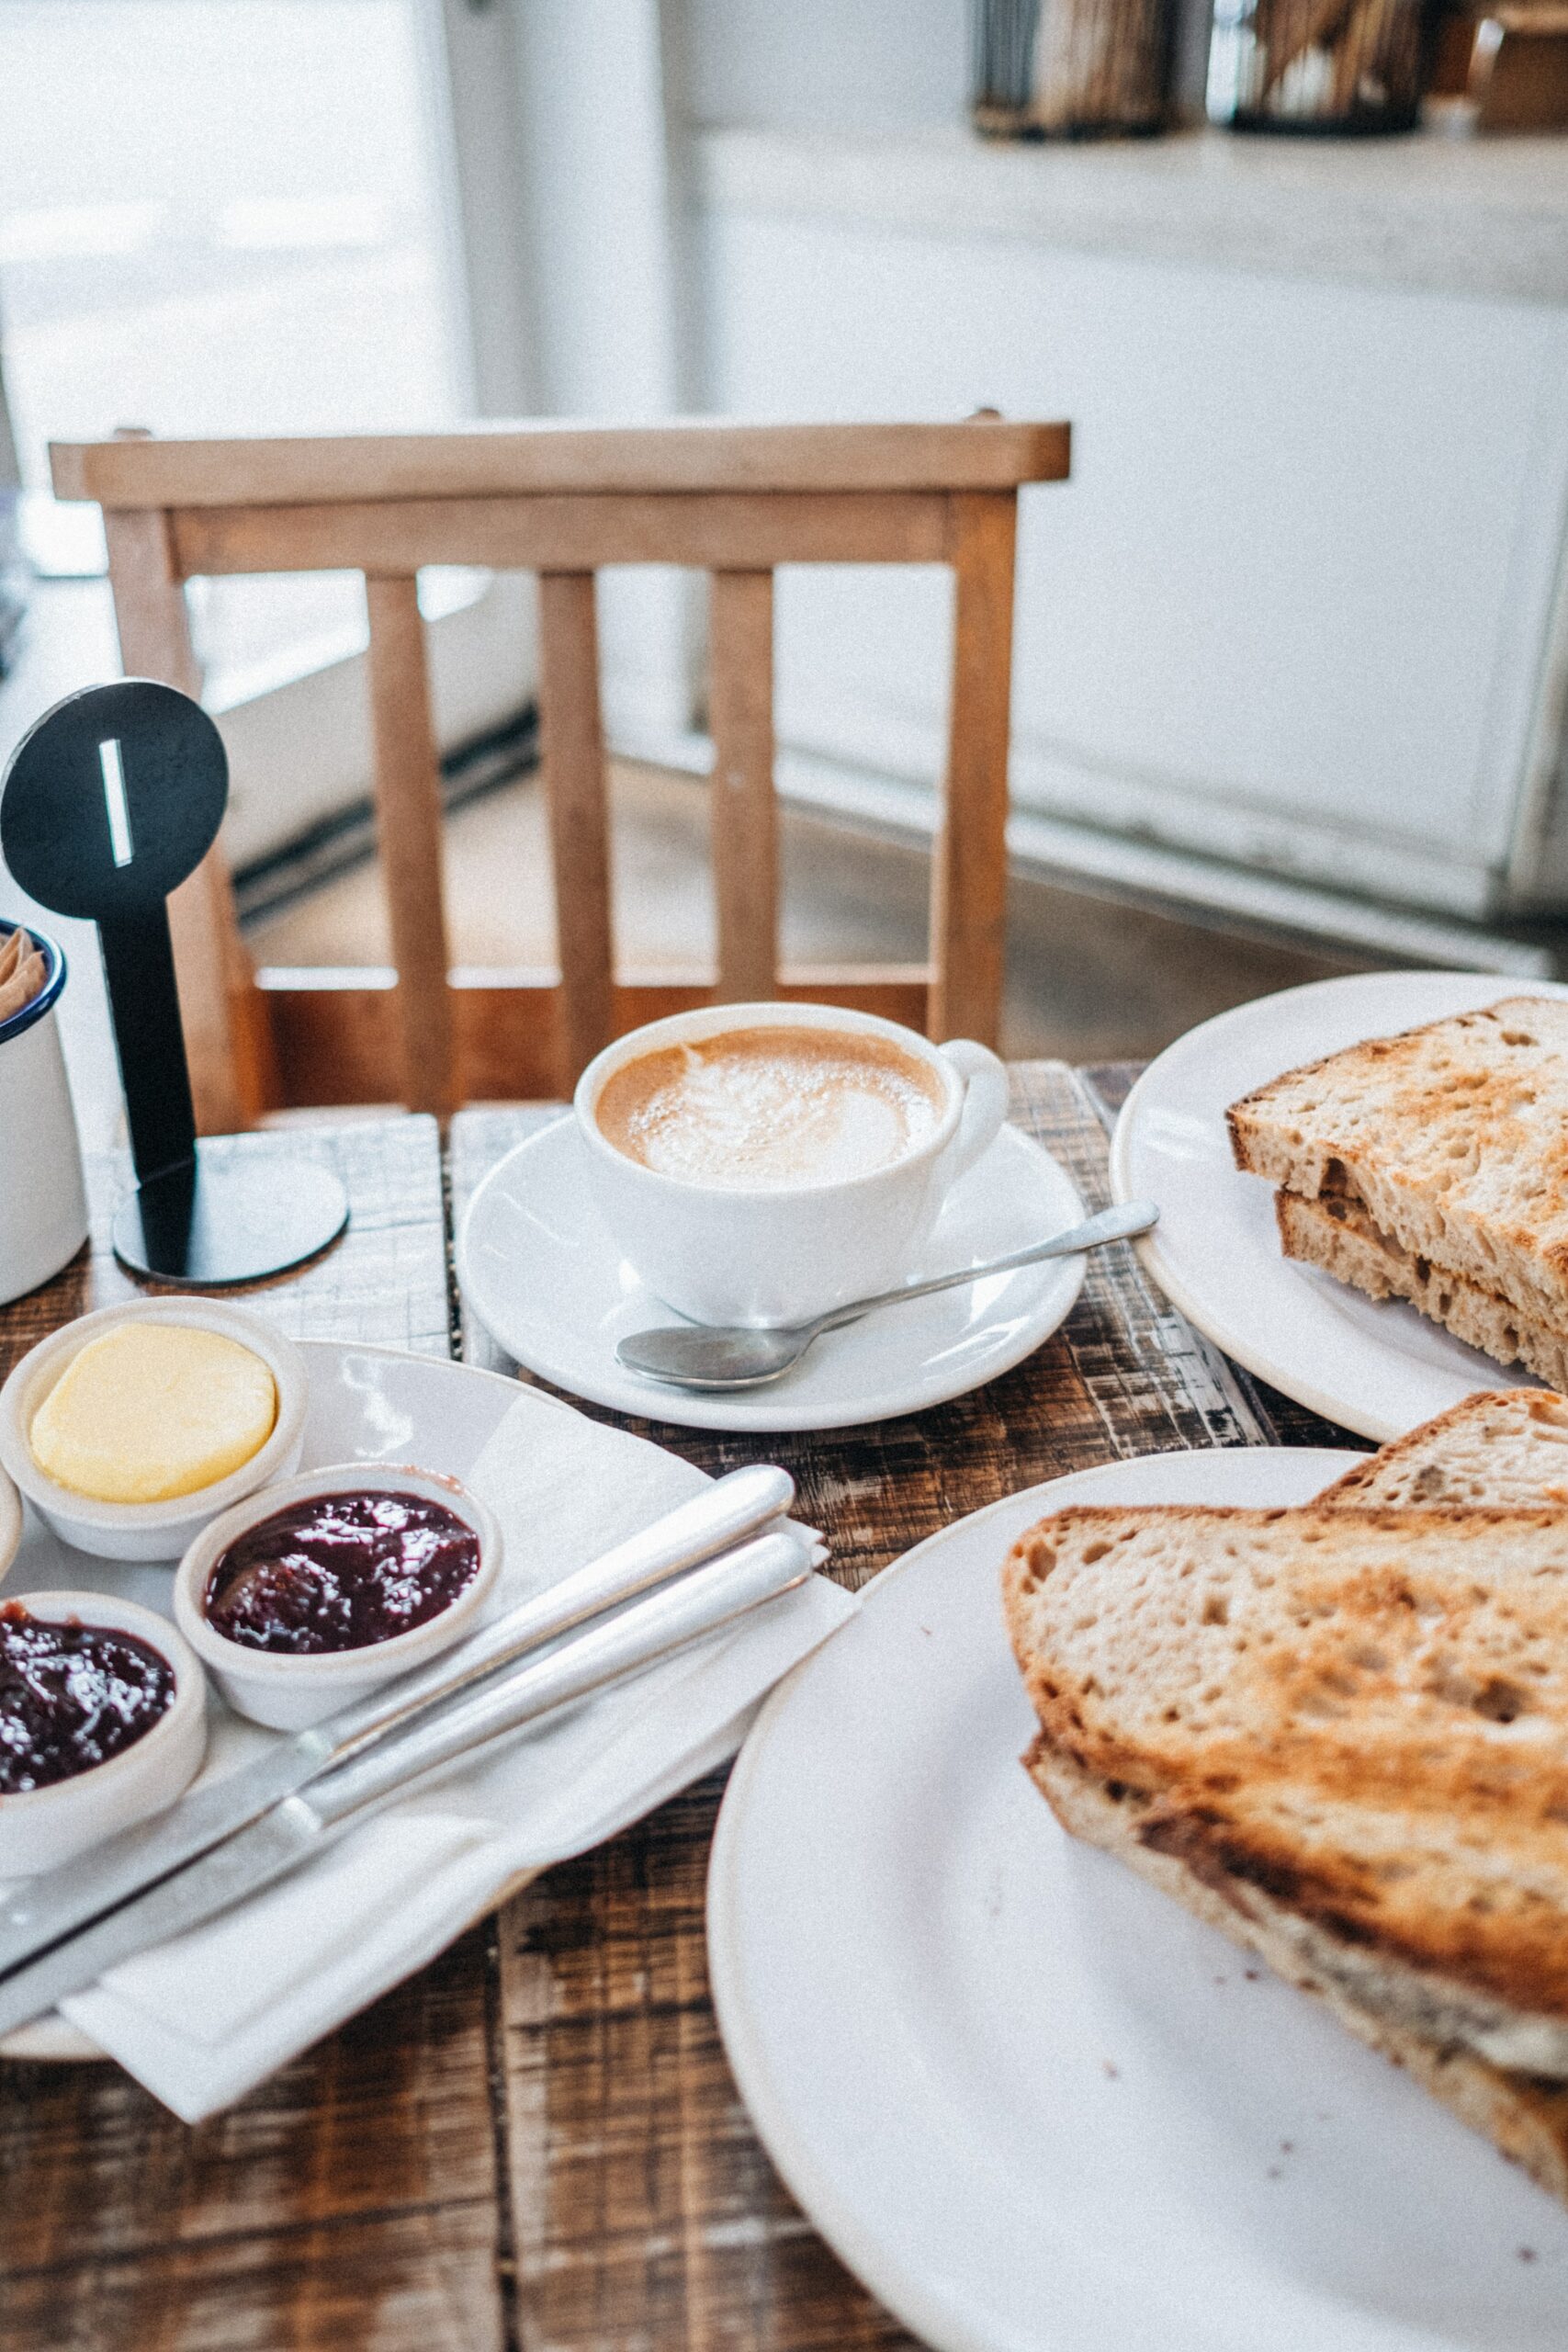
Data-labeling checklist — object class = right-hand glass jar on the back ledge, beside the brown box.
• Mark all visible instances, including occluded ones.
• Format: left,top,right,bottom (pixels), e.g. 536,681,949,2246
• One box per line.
1208,0,1429,134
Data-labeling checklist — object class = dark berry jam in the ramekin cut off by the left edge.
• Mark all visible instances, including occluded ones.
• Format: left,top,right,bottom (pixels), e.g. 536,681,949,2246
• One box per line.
0,1601,174,1797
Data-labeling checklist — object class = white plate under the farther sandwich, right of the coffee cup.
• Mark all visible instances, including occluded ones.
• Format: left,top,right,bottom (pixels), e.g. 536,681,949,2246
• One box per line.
1110,971,1568,1442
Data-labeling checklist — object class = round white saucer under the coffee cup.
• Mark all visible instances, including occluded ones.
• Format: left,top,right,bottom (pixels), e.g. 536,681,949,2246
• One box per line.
458,1114,1084,1430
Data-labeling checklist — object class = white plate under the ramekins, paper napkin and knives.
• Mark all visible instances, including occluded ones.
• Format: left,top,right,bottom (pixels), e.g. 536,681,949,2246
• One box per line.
0,1340,567,2058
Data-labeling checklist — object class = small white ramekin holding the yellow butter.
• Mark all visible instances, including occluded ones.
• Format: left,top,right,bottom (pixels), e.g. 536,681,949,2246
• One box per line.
0,1298,308,1559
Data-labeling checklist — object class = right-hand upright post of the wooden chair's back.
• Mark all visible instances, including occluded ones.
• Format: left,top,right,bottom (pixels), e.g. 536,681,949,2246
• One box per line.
929,492,1018,1046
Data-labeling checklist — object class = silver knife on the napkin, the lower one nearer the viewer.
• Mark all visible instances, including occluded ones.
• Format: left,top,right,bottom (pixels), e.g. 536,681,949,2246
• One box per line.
0,1529,811,2034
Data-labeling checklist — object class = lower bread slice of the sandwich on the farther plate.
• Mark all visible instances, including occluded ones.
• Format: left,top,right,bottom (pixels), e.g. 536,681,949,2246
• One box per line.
1274,1193,1568,1387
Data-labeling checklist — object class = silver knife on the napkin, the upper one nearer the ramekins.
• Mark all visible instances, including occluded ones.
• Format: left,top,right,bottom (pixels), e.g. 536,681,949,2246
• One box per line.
0,1463,795,1981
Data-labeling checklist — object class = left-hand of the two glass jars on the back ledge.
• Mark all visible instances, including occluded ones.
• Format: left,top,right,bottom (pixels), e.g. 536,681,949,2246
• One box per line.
971,0,1176,139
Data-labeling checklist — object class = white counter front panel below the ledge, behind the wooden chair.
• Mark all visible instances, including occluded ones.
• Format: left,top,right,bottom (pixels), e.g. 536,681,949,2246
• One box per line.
705,199,1565,912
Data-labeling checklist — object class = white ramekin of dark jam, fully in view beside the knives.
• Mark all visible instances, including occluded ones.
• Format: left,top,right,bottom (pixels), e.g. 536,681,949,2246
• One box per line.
174,1463,503,1731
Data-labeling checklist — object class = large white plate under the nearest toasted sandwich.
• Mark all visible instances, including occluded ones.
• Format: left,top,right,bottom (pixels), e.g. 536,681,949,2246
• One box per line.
707,1449,1568,2352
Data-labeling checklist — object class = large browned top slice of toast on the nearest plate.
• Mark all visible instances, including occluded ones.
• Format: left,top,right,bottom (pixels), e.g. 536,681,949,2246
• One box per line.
1004,1508,1568,2079
